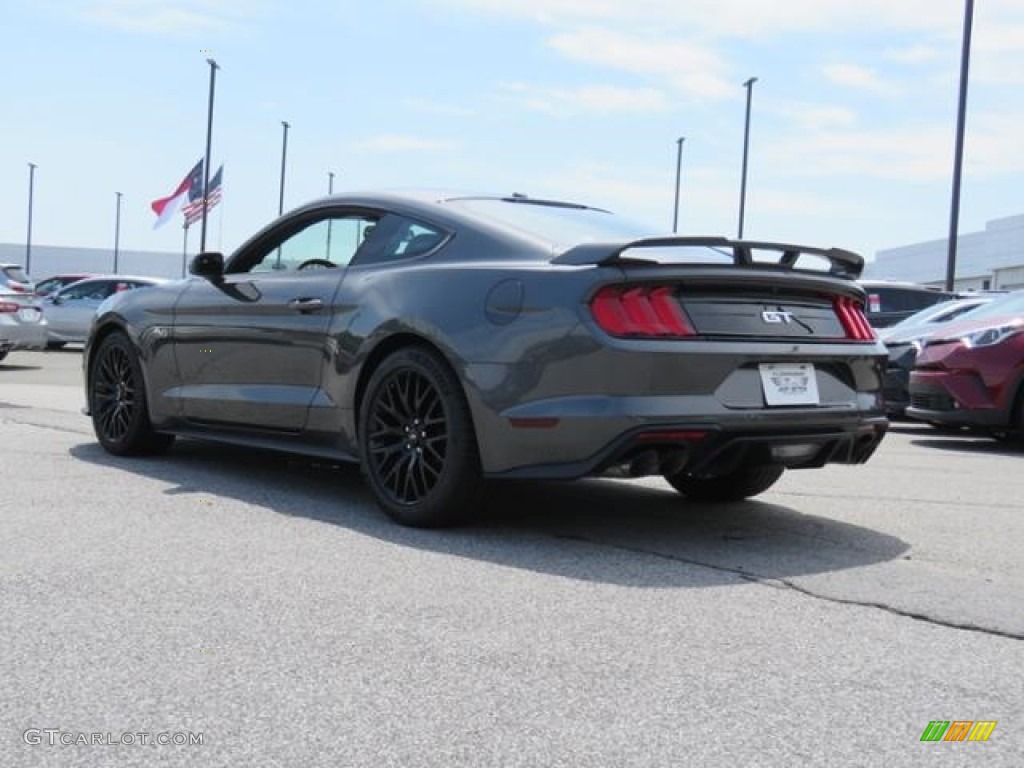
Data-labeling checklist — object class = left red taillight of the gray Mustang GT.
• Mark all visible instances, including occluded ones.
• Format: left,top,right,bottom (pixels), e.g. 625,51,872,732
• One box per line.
590,286,696,337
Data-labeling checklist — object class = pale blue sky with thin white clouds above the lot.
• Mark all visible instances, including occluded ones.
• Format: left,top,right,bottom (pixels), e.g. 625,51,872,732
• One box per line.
0,0,1024,264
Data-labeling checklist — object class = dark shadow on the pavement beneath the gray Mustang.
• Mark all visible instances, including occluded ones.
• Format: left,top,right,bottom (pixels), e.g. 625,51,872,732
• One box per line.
71,440,909,588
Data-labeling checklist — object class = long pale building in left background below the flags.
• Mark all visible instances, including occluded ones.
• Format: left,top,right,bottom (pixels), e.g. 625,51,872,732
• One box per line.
0,243,184,281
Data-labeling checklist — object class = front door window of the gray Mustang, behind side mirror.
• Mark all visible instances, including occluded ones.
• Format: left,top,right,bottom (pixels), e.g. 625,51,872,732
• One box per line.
244,216,377,272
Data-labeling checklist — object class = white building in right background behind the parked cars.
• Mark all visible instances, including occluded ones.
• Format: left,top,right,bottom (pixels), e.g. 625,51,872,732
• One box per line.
864,214,1024,291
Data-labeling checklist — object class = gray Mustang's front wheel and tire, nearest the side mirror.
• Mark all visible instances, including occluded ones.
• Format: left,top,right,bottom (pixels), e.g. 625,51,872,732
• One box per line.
89,333,174,456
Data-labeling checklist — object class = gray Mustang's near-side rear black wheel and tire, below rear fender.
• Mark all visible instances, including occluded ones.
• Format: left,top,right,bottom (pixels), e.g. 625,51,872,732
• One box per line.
359,347,481,527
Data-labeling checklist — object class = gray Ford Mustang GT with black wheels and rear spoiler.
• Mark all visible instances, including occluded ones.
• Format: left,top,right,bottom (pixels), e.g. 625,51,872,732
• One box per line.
83,194,888,526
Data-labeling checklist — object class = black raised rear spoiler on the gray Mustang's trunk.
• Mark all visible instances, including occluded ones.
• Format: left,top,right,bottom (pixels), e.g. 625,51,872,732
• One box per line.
551,237,864,280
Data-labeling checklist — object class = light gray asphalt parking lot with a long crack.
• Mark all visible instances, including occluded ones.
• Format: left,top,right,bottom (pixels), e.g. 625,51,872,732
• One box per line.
0,349,1024,767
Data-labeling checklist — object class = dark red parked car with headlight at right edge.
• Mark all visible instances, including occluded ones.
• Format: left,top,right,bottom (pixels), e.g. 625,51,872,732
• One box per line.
906,291,1024,438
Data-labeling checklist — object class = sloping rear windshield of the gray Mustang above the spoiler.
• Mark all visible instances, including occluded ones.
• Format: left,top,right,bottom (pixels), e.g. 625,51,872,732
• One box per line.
449,198,658,248
